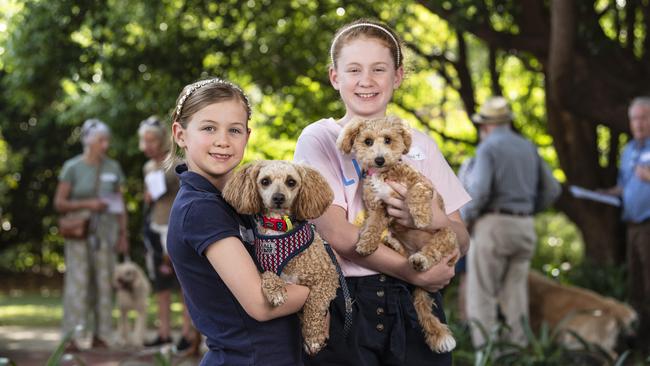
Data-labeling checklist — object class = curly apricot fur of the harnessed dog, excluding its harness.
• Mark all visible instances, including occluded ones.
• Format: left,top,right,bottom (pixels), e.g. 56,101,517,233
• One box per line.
223,161,339,354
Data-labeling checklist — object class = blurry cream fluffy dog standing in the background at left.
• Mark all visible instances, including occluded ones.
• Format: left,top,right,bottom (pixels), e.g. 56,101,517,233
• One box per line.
113,261,151,347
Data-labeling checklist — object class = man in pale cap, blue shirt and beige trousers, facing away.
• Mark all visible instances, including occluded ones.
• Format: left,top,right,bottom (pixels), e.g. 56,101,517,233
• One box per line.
461,97,561,347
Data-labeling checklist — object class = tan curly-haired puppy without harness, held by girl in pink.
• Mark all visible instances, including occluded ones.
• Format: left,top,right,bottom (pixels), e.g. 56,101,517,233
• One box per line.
337,116,458,352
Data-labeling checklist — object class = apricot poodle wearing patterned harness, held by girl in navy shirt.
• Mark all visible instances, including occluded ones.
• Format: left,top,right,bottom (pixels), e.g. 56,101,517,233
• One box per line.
223,161,339,354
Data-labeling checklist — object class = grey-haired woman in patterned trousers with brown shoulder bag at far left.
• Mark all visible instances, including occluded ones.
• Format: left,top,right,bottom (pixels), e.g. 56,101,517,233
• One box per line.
54,119,129,351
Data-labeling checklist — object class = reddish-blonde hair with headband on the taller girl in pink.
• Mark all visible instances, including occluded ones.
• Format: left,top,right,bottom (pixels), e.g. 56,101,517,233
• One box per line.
330,19,404,69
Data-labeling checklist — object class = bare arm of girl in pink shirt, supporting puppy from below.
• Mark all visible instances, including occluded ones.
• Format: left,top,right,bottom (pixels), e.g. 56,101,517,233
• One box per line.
313,205,454,292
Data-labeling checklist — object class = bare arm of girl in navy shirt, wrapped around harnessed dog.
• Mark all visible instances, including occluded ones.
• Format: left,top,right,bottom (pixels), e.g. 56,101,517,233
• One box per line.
205,236,309,321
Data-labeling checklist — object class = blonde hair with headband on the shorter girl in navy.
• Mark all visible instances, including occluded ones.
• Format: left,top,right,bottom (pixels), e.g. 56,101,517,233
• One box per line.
163,78,251,169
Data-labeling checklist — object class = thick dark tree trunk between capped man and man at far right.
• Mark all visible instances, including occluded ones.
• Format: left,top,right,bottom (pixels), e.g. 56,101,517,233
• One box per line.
546,0,625,263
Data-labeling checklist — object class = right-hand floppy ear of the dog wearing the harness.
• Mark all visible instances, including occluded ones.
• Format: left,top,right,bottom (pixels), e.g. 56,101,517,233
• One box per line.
294,164,334,220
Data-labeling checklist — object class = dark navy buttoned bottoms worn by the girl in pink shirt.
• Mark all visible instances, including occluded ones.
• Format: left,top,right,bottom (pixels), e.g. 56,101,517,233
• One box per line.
304,275,452,366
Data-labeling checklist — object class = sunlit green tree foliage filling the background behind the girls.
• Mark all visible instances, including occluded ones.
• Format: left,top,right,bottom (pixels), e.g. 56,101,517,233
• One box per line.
0,0,645,271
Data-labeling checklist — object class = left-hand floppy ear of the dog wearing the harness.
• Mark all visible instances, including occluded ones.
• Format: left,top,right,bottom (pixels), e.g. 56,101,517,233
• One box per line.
223,161,264,215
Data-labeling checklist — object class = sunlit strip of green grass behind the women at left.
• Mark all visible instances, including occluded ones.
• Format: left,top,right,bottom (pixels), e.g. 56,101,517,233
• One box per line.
0,290,183,328
